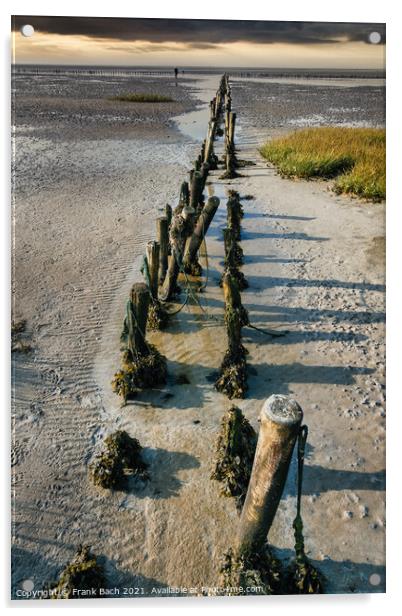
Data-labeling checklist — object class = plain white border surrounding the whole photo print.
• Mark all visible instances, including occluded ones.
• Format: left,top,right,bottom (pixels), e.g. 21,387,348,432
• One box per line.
0,0,402,616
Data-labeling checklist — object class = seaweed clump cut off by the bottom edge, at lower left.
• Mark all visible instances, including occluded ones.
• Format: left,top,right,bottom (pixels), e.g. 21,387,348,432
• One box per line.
48,545,106,599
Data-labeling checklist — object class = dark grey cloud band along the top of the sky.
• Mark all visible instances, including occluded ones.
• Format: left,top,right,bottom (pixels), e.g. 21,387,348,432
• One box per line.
12,15,385,49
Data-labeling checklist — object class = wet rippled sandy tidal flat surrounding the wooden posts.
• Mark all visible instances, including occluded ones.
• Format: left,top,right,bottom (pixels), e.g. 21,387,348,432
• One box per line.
12,68,385,598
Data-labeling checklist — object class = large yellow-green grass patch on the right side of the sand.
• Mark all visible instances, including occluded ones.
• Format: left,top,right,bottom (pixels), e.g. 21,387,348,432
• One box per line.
260,127,385,201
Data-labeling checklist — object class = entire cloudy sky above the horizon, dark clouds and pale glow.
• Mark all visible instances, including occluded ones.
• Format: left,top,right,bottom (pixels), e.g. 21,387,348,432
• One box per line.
12,15,385,69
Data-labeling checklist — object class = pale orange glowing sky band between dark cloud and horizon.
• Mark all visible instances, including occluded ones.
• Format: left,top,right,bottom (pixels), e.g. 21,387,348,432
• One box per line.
13,32,385,70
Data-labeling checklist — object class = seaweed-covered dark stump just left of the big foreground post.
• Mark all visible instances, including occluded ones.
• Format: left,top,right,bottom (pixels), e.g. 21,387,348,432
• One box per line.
211,406,257,511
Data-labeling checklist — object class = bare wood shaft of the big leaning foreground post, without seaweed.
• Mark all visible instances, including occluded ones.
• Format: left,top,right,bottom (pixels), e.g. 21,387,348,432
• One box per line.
236,395,303,555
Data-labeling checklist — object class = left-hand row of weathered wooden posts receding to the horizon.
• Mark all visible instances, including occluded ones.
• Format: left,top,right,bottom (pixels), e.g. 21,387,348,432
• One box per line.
112,75,234,400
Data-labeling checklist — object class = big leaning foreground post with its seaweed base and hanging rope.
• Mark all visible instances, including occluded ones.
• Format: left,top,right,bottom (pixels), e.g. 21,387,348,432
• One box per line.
220,395,323,595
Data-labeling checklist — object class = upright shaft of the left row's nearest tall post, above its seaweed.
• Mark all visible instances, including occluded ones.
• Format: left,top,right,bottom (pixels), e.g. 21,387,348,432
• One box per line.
127,282,151,357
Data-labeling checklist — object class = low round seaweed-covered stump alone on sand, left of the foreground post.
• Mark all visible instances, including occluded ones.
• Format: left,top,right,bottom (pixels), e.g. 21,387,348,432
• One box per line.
89,430,148,489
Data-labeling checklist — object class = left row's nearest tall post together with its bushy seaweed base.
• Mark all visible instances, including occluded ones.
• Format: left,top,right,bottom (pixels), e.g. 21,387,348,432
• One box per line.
112,283,167,402
